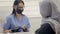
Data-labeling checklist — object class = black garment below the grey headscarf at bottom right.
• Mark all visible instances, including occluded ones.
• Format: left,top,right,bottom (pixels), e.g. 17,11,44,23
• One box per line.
35,23,55,34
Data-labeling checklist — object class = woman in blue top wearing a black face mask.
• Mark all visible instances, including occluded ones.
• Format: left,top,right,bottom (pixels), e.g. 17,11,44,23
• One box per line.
3,0,30,33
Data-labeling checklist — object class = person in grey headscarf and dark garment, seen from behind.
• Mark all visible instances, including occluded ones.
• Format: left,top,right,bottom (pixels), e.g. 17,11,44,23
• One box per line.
36,0,60,34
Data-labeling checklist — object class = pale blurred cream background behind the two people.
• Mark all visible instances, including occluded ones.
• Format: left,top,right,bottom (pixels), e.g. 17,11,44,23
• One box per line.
0,0,60,33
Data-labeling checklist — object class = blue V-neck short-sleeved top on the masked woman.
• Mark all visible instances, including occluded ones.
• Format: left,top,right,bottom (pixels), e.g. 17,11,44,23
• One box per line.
3,14,30,31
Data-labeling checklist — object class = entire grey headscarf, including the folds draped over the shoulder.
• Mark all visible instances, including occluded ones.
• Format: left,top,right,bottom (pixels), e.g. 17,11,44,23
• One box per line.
40,0,60,34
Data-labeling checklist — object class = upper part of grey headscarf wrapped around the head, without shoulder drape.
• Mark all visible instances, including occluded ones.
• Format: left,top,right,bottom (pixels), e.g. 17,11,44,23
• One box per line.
40,0,60,22
